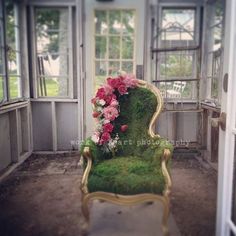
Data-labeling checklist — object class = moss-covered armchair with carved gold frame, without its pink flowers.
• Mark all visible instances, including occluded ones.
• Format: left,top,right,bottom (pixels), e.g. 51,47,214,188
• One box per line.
81,80,173,235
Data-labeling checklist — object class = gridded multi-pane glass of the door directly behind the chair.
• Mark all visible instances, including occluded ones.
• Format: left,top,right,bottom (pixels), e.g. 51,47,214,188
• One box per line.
94,10,135,87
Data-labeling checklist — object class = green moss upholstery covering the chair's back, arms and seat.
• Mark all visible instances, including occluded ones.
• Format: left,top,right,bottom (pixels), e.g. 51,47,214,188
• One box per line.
81,88,173,194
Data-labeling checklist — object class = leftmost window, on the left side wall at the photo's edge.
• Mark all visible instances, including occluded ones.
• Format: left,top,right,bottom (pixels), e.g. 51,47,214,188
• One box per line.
0,0,22,103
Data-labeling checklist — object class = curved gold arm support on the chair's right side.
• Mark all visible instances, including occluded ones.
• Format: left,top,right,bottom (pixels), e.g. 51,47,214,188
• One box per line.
161,148,172,197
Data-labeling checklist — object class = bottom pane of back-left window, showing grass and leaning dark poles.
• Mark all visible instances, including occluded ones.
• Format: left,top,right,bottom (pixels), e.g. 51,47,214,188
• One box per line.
38,76,68,97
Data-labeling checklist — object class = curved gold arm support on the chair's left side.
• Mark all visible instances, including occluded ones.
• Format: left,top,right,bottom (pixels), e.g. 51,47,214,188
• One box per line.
81,147,92,194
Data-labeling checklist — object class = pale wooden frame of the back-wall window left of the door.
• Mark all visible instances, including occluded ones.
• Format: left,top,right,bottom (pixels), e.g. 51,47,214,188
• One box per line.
29,5,74,100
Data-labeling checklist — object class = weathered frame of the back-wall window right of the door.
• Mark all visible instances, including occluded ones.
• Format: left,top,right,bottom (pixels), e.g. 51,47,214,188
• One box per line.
151,3,201,102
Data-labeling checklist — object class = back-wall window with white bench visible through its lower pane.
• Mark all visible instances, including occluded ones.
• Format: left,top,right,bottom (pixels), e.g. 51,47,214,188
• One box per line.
152,7,198,99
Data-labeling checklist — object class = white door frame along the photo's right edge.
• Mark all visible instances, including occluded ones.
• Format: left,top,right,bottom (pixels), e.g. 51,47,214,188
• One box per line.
216,0,236,236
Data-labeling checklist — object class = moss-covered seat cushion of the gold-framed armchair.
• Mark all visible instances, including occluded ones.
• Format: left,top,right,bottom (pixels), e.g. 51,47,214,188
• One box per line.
88,156,165,195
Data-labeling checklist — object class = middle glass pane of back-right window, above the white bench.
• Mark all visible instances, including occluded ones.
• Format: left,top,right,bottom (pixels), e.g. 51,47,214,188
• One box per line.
159,52,195,79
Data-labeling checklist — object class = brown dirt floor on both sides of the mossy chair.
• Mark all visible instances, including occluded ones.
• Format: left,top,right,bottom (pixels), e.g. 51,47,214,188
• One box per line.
0,154,217,236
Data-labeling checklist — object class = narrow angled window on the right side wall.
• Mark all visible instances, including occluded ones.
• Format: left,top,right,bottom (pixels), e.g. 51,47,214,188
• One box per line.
207,0,224,105
